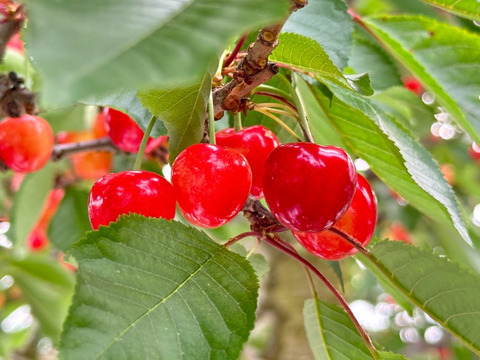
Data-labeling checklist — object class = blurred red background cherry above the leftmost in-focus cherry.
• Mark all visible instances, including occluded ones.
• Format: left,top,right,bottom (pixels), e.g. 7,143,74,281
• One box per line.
104,108,164,153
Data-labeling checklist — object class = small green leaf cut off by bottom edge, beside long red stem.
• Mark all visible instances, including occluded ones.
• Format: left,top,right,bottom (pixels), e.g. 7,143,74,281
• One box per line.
303,299,373,360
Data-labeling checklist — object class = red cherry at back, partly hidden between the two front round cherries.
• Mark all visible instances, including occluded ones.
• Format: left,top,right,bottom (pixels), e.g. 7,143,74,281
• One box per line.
215,125,280,199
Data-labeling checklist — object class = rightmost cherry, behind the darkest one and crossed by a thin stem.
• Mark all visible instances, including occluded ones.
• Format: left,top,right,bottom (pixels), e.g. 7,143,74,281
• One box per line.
292,175,377,260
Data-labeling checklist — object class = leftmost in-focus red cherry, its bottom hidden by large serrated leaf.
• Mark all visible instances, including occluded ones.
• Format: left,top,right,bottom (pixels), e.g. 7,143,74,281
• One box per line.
88,171,176,229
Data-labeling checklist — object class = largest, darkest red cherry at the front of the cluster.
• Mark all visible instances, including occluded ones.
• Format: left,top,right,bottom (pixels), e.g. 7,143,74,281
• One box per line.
263,143,357,232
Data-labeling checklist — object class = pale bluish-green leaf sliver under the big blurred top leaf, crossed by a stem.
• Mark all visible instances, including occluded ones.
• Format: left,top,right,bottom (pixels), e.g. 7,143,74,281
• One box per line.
82,90,167,137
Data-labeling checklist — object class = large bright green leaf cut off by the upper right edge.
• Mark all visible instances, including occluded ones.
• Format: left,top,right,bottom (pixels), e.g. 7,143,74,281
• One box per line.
364,16,480,143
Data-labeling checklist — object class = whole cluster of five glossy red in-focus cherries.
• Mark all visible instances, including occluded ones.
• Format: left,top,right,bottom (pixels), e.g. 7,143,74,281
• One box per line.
88,109,377,260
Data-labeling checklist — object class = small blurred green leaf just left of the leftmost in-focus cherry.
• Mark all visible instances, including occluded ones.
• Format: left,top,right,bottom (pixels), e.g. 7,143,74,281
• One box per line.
48,187,92,252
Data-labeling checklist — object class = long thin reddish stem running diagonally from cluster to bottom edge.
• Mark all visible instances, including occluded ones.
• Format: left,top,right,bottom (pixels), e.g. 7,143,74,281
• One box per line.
263,235,378,359
